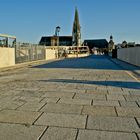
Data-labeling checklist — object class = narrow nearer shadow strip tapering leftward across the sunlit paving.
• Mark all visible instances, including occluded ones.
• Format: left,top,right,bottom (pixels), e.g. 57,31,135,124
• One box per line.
40,79,140,89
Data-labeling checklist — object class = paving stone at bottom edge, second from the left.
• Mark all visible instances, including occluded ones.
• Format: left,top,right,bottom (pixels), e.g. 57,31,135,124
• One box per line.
41,127,77,140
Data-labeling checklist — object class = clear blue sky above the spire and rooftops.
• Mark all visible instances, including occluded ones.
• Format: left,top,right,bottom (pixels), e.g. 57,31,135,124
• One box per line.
0,0,140,43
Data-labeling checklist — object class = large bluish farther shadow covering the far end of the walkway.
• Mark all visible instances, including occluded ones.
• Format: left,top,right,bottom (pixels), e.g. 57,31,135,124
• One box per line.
33,55,140,70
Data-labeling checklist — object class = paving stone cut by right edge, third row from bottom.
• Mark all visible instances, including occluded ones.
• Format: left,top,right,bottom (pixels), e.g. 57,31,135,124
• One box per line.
116,107,140,117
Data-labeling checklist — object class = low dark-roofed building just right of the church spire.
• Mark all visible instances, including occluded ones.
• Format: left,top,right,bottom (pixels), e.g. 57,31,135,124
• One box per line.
83,39,108,53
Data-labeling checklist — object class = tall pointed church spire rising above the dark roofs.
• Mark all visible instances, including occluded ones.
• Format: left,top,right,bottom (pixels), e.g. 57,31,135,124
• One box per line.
72,8,81,46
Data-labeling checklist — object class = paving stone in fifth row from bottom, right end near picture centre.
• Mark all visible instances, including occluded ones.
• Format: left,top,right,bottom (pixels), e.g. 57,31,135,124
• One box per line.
42,91,75,98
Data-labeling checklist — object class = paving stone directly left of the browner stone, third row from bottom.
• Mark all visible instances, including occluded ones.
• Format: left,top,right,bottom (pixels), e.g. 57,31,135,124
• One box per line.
41,103,83,114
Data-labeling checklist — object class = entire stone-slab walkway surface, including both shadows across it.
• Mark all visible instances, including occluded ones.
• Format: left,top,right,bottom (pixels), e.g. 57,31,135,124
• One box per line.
0,56,140,140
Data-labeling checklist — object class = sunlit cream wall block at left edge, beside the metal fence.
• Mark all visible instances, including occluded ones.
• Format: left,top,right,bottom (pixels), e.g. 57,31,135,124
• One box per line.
0,47,15,68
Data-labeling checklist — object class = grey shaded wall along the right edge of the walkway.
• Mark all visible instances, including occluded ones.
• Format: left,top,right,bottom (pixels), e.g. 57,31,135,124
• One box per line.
117,47,140,66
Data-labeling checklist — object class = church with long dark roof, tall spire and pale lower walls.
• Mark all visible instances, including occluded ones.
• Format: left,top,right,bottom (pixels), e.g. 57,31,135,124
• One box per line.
39,8,89,57
